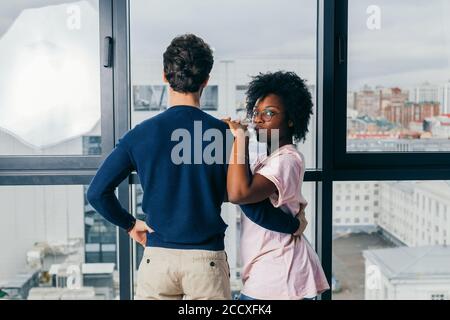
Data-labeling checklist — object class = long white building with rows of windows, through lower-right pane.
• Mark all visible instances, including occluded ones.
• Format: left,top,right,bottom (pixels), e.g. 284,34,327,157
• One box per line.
333,181,450,247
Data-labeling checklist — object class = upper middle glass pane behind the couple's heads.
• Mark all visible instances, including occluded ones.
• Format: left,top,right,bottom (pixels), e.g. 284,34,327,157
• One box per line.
130,0,317,168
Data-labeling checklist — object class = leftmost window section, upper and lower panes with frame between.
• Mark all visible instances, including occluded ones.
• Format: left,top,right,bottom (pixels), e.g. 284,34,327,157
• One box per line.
0,0,121,300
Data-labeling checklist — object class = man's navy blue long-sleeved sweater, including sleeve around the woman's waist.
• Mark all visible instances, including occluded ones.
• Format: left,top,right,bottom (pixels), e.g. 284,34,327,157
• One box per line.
87,106,299,251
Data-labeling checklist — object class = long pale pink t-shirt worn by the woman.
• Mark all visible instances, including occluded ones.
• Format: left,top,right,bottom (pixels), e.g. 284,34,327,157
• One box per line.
241,145,330,300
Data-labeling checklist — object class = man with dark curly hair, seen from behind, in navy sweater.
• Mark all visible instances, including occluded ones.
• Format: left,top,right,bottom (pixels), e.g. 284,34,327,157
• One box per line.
87,34,304,300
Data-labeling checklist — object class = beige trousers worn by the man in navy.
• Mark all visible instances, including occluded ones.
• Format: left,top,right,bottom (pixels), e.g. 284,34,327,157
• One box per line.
135,247,231,300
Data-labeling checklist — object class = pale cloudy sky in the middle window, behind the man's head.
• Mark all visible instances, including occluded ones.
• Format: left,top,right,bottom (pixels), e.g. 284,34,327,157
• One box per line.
130,0,317,59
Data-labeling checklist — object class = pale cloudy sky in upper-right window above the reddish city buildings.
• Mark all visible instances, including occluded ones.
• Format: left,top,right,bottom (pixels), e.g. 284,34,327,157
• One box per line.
348,0,450,90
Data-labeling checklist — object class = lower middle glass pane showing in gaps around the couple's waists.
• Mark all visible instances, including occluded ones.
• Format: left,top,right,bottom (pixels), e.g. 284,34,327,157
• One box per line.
132,182,316,297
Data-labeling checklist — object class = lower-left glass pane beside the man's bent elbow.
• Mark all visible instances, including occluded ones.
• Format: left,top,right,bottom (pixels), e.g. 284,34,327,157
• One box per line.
0,185,119,300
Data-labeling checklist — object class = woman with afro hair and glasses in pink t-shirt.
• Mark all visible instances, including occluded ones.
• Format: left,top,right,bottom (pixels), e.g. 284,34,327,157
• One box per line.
224,71,330,300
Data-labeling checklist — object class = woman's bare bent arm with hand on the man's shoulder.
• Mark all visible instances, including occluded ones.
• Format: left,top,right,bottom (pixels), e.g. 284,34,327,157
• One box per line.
226,120,277,204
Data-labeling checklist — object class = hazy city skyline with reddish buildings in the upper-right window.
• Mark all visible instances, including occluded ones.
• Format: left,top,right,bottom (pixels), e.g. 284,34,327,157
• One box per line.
347,81,450,146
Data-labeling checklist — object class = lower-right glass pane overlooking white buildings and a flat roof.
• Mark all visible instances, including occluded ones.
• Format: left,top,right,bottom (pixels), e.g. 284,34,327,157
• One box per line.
333,181,450,300
